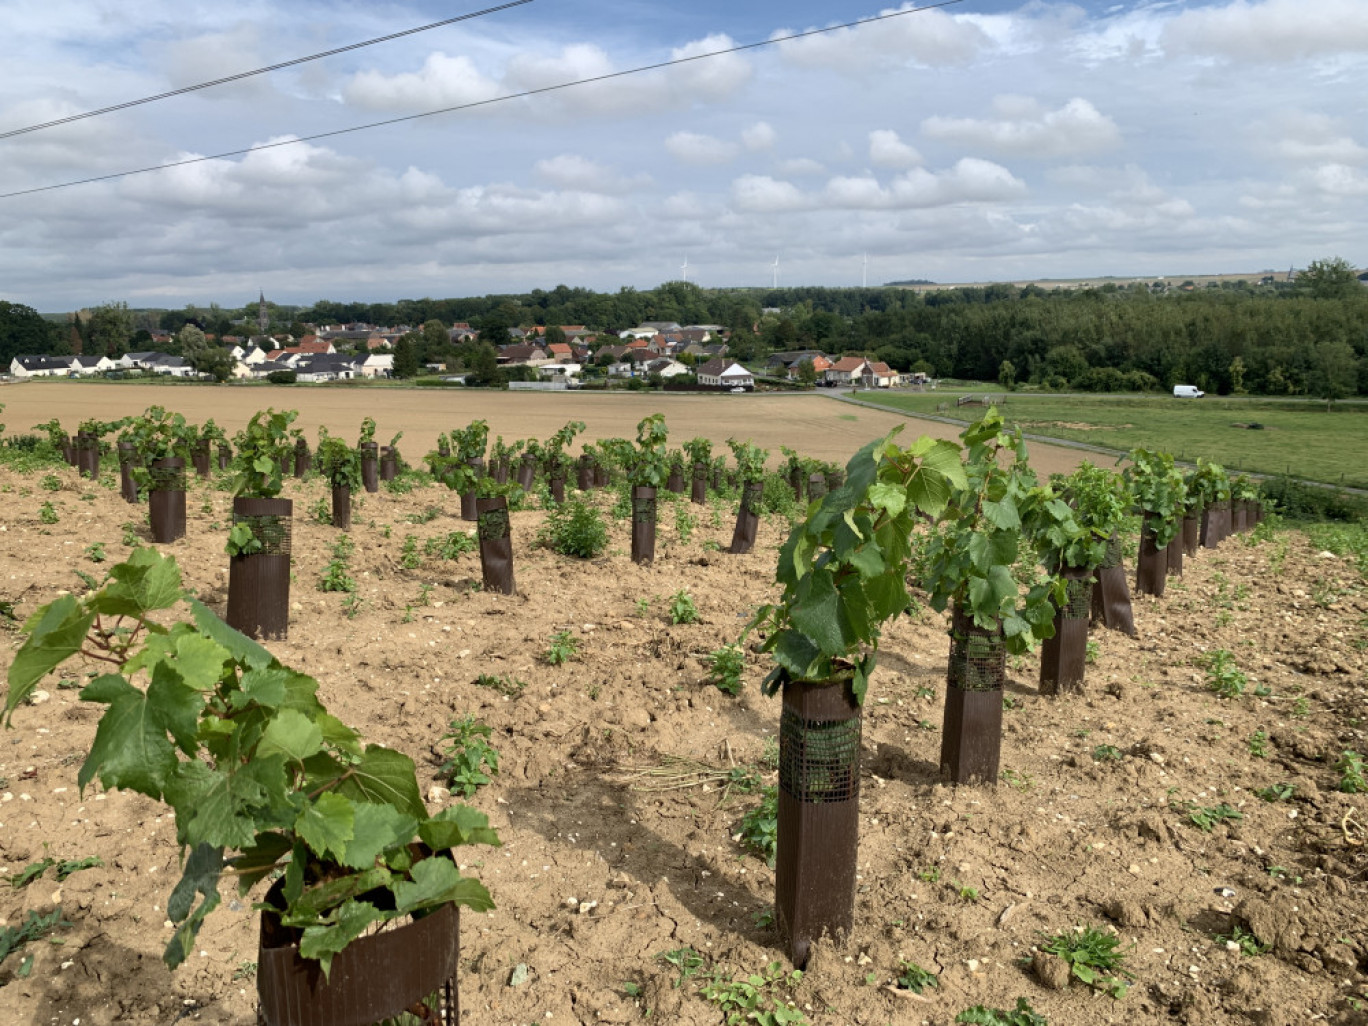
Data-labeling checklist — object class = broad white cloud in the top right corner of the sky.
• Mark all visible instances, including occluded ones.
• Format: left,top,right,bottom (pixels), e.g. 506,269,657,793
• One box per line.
1161,0,1368,64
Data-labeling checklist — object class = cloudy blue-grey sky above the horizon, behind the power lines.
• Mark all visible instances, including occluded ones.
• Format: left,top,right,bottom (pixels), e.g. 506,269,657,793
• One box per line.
0,0,1368,311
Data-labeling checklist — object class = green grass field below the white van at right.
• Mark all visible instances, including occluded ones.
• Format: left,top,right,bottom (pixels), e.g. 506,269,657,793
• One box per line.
858,389,1368,488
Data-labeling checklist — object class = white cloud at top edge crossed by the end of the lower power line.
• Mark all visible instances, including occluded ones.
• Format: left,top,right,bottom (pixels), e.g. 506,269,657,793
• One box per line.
774,4,990,74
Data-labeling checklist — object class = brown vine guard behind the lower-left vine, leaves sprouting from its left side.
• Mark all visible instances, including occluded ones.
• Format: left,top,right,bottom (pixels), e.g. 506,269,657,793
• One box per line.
227,498,294,640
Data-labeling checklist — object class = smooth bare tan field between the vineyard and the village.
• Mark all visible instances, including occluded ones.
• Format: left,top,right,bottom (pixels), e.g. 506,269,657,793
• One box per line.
0,382,1082,475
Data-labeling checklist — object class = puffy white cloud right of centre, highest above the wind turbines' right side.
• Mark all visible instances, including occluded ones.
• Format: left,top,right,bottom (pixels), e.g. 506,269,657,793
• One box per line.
922,96,1122,160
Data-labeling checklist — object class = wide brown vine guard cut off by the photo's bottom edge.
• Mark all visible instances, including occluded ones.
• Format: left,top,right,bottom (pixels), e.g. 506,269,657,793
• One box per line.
257,881,461,1026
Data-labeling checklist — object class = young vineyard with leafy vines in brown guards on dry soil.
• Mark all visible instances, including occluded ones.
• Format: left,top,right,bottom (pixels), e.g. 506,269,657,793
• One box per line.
0,410,1368,1026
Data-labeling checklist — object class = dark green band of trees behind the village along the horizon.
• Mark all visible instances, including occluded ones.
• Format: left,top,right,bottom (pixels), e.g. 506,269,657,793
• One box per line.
0,259,1368,398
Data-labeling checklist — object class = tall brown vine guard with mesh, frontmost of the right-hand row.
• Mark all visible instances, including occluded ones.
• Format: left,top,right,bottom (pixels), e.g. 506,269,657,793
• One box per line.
774,677,862,969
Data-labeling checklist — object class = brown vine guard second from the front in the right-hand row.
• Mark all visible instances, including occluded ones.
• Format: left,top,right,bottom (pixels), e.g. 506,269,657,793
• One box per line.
940,609,1007,787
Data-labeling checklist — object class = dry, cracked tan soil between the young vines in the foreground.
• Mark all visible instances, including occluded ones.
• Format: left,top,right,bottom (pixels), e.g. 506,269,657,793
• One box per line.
0,459,1368,1026
